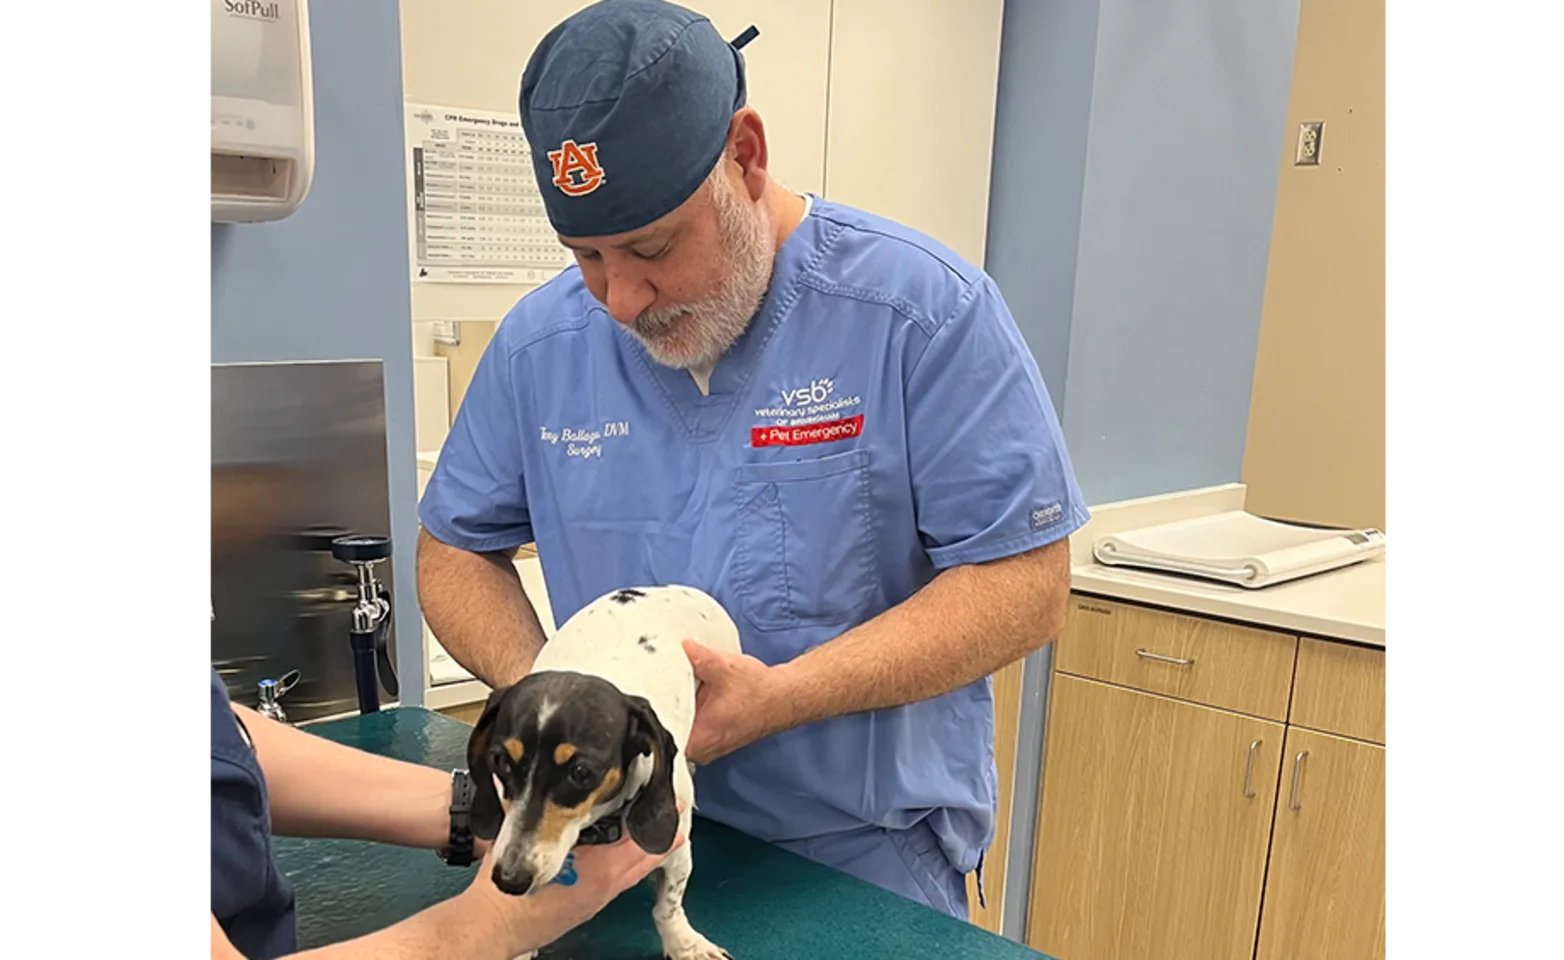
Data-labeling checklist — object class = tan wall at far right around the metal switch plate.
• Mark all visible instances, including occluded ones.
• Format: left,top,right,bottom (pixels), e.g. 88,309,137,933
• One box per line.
1243,0,1390,533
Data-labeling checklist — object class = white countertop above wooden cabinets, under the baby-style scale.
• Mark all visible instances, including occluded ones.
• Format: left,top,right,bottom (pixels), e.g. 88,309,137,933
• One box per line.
1070,483,1390,649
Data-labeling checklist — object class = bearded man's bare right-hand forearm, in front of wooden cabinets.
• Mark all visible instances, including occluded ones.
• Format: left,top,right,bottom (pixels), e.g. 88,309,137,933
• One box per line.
777,541,1070,727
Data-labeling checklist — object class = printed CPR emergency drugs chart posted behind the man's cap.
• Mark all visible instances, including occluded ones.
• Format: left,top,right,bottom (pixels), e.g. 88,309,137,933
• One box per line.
405,103,572,285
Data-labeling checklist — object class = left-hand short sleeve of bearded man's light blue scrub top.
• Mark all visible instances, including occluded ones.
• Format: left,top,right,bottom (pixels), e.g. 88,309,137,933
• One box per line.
418,331,532,552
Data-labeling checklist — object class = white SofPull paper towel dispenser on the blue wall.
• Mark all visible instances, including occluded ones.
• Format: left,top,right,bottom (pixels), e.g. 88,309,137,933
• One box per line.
206,0,314,224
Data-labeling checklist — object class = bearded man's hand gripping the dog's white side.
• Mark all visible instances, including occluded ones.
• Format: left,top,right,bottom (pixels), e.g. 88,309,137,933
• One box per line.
683,639,791,765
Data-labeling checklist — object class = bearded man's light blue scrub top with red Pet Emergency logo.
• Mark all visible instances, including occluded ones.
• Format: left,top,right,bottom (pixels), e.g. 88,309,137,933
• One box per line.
419,197,1089,894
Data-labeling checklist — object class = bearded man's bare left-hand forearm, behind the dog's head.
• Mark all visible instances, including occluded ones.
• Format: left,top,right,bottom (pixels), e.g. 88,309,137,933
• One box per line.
418,530,546,688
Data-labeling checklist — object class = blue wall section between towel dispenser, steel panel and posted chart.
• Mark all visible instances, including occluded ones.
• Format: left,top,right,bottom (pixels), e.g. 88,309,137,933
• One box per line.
206,0,424,704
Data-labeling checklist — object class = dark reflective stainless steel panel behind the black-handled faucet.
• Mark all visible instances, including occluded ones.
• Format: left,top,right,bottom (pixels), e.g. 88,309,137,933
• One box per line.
206,361,396,722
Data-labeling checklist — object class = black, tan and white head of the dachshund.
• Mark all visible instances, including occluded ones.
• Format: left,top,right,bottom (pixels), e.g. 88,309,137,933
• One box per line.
468,671,679,896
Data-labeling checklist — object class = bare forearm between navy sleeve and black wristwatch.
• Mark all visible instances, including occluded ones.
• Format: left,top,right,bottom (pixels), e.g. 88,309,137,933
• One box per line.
233,704,450,851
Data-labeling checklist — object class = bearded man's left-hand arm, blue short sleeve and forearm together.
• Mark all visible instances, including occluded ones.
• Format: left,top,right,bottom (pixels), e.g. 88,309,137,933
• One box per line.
418,327,546,688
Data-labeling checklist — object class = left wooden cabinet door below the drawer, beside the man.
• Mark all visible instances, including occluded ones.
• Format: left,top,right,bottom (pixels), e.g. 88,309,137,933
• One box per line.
1029,674,1282,960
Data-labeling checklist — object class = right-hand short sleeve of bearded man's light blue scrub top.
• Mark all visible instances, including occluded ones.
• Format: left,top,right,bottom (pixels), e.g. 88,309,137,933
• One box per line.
906,277,1090,569
